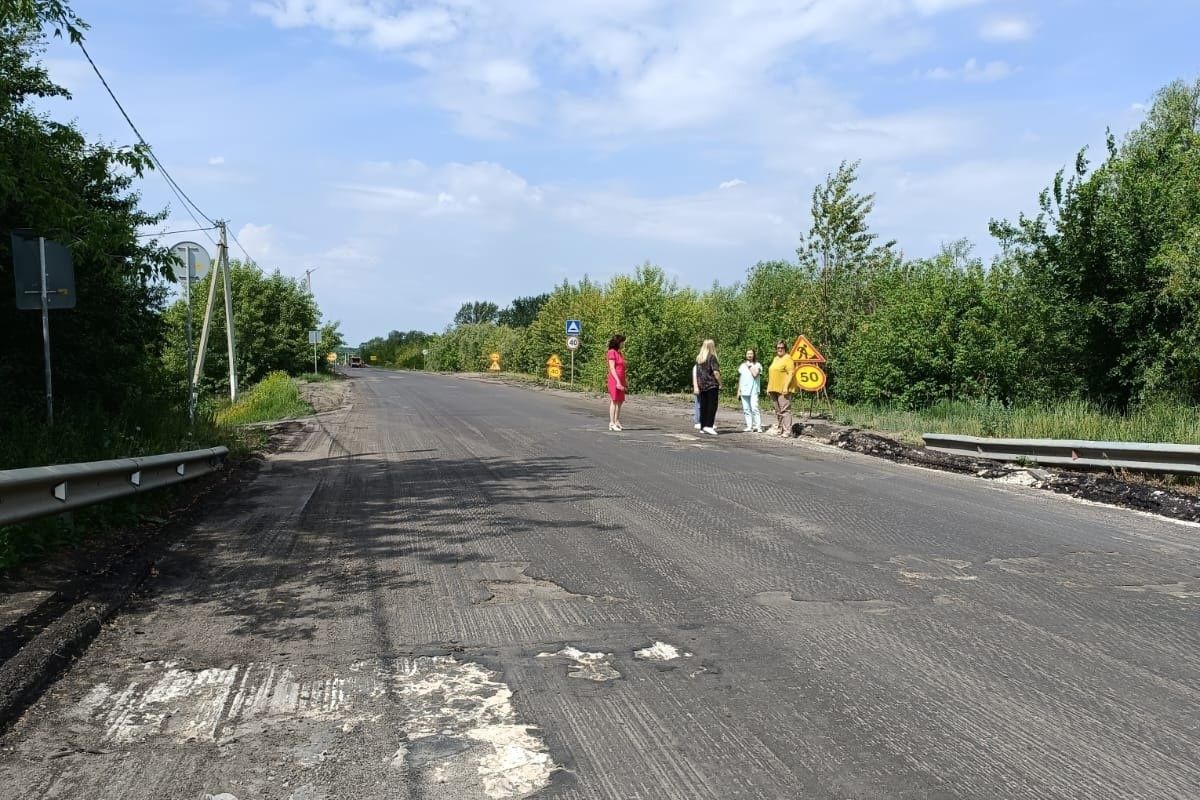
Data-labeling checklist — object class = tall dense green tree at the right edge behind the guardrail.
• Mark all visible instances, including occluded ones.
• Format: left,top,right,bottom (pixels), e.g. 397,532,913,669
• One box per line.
992,80,1200,407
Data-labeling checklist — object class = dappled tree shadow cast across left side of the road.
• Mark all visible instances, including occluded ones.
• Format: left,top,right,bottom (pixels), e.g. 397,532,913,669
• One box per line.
134,453,619,642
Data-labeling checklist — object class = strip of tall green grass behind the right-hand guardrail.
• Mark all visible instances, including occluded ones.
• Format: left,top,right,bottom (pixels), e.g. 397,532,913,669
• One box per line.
830,401,1200,444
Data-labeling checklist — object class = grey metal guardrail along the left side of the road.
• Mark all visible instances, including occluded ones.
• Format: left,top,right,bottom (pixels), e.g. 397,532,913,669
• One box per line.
0,447,229,525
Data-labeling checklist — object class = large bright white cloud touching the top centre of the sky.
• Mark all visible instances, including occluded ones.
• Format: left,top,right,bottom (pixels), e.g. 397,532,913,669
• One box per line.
252,0,1003,145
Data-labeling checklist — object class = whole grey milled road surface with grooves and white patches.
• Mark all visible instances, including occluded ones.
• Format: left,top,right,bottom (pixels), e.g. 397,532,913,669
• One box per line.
0,369,1200,800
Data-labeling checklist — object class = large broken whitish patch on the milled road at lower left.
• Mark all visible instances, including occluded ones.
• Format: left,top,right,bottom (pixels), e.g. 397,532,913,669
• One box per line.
71,651,552,800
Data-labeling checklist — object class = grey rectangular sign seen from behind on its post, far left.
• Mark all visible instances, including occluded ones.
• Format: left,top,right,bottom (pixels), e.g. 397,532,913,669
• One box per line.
12,230,76,425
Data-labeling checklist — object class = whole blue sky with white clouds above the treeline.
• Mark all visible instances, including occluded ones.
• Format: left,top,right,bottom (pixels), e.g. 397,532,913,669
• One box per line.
37,0,1200,342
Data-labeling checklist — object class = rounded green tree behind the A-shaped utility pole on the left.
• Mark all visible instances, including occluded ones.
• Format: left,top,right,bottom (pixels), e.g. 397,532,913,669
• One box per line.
163,260,343,396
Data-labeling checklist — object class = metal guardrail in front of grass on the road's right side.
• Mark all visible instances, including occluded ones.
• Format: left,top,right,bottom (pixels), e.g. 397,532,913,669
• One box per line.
922,433,1200,475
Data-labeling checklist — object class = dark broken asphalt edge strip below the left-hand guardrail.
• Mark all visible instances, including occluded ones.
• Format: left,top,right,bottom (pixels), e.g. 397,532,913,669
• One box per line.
0,457,262,733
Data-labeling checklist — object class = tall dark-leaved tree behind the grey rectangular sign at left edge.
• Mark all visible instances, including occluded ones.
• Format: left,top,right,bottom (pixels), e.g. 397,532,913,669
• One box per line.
0,17,176,424
